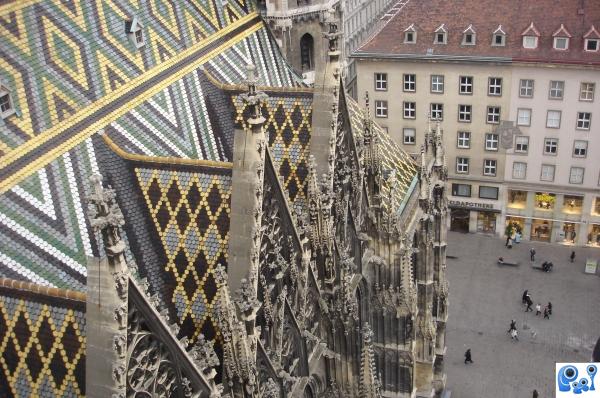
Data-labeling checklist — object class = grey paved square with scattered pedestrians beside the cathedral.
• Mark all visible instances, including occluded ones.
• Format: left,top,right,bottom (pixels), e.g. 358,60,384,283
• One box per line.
445,232,600,398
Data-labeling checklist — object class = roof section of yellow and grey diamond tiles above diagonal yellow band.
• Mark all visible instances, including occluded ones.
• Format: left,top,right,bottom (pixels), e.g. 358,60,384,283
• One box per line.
0,0,252,156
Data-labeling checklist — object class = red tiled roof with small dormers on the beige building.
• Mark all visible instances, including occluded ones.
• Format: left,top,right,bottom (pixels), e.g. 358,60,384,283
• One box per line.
354,0,600,65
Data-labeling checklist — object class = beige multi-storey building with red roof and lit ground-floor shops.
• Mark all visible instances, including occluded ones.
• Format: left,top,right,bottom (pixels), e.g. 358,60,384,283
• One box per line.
352,0,600,246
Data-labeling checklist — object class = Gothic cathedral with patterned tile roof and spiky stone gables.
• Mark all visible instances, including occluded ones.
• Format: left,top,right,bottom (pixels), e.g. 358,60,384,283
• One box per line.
0,0,448,398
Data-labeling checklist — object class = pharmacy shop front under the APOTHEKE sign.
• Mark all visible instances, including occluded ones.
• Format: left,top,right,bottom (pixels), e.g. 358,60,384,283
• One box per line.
448,200,500,234
